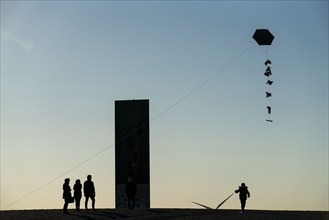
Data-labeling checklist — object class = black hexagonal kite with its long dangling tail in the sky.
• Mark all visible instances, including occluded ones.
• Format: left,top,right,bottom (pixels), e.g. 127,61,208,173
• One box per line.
252,29,274,122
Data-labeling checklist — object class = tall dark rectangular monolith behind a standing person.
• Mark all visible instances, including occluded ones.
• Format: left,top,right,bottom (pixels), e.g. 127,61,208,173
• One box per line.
115,99,150,208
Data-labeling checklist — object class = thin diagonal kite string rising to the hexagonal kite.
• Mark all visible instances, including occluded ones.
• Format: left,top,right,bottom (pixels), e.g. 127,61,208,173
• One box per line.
1,44,255,209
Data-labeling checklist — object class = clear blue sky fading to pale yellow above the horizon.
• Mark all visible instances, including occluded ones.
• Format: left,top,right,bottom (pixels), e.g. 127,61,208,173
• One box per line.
0,0,329,211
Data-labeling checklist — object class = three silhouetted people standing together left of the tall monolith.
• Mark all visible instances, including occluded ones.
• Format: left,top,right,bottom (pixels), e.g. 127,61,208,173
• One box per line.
63,175,96,214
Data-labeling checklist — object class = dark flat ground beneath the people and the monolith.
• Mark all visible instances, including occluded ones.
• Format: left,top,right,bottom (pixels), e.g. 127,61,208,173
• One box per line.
0,209,329,220
